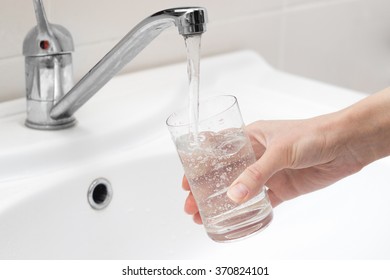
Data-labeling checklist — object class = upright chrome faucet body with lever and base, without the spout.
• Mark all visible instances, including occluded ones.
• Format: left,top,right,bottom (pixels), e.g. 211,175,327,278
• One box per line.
23,0,75,130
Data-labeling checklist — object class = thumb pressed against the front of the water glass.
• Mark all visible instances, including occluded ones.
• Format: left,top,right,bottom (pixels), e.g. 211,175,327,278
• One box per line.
227,151,283,203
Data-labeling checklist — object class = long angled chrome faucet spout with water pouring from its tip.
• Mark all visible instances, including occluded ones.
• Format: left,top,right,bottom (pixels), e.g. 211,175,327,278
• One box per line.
50,7,207,120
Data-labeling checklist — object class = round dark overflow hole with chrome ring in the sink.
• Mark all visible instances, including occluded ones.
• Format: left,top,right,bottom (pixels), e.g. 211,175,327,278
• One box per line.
88,178,112,210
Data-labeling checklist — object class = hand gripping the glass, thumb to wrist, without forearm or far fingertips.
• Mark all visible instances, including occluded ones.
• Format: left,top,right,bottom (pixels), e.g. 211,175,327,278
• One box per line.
227,114,363,207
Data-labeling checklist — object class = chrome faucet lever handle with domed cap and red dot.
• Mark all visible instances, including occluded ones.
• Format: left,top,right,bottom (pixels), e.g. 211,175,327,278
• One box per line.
23,0,74,56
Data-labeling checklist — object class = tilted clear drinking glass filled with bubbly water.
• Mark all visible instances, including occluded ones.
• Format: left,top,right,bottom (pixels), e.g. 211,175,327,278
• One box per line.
167,95,273,242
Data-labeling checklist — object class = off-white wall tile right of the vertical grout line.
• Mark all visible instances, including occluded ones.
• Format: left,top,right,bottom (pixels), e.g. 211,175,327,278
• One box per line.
279,0,390,92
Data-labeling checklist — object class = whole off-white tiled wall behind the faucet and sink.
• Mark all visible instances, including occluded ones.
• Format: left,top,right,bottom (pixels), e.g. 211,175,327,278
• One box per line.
0,0,390,101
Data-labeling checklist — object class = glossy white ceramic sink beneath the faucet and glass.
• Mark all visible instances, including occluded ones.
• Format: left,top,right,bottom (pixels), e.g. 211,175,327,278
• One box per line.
0,51,390,259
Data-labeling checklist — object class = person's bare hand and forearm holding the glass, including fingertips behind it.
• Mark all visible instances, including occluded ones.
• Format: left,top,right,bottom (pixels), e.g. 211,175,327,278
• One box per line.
182,88,390,224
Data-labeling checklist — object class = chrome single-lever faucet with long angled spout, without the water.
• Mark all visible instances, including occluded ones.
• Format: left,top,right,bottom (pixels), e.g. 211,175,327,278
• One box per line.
23,0,207,130
